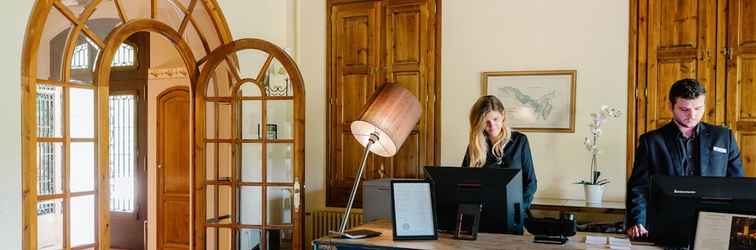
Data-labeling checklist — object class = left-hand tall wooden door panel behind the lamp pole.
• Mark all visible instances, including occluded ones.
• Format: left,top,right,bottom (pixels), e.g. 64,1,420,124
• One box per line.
326,1,381,207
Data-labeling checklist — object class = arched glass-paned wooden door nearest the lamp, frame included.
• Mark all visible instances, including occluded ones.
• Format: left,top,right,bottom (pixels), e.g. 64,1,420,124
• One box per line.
194,39,305,249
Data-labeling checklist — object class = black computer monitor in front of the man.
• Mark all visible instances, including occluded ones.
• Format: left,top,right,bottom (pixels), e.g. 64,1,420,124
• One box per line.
646,175,756,247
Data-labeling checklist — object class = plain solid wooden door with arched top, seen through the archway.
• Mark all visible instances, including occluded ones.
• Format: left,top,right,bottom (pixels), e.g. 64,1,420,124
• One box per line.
157,88,191,250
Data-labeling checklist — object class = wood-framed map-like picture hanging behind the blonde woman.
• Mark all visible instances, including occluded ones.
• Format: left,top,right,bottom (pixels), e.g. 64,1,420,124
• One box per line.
481,70,577,133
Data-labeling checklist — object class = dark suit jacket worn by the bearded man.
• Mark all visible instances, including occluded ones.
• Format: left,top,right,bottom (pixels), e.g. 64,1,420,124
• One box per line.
625,122,743,226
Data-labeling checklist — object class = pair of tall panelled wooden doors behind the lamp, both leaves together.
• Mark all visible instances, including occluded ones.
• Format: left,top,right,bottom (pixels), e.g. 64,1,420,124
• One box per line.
326,0,440,207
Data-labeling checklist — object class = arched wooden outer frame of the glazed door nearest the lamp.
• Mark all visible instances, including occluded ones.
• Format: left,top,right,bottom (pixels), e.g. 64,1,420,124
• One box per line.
192,38,306,250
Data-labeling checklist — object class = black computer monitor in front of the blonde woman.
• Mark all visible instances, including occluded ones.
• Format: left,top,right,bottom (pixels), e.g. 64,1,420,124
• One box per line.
425,166,524,234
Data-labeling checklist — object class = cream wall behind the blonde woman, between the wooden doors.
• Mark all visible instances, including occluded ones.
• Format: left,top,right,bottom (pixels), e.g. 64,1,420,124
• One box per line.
441,0,629,201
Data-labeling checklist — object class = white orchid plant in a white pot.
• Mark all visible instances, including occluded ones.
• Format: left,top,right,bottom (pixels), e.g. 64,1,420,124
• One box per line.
575,105,622,185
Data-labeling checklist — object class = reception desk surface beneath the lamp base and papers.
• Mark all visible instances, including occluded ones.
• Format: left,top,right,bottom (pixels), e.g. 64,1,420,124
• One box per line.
312,220,662,250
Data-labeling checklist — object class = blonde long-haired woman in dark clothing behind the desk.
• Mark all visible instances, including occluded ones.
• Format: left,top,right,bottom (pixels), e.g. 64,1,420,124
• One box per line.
462,95,537,211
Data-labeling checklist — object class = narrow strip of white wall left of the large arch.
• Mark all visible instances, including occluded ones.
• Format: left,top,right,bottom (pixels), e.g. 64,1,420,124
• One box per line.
0,1,34,249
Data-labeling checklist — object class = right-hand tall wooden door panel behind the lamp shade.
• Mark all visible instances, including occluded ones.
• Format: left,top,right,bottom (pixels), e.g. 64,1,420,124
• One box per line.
383,0,436,178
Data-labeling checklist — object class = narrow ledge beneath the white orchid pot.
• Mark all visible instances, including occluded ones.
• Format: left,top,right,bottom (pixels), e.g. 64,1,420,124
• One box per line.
530,198,625,214
